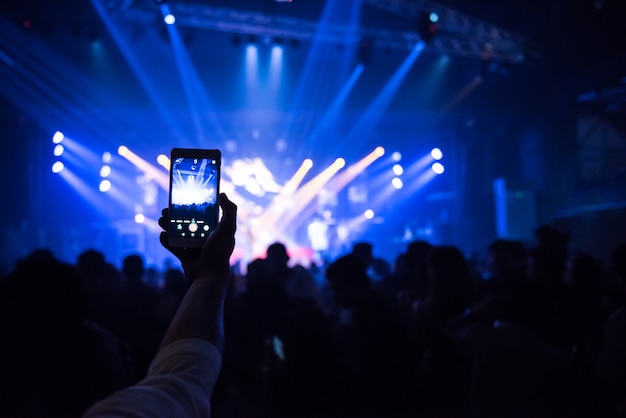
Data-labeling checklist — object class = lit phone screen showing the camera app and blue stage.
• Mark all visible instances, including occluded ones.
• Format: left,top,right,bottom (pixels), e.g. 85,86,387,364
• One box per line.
170,158,218,238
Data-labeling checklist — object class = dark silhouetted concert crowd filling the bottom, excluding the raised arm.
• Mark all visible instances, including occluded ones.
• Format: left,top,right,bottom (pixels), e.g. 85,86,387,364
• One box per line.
0,220,626,418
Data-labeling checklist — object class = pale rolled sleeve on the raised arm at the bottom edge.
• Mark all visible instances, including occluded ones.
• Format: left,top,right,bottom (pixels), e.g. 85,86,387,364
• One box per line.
84,338,222,418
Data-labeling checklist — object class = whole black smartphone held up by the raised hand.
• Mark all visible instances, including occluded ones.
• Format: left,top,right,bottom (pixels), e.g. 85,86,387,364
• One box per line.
168,148,222,248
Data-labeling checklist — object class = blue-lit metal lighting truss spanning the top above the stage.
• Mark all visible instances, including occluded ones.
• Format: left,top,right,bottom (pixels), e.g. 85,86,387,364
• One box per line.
114,0,525,64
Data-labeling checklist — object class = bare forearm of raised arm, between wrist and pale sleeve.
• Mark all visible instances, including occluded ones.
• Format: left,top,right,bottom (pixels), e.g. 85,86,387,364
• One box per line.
161,277,228,351
